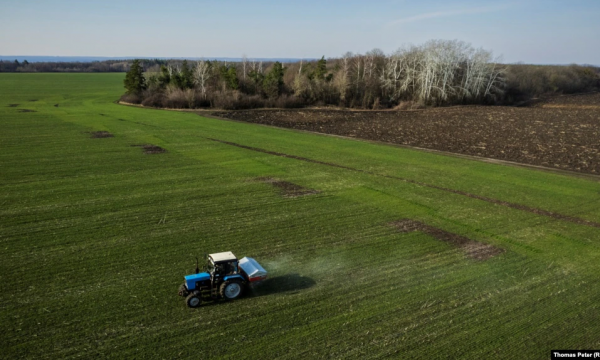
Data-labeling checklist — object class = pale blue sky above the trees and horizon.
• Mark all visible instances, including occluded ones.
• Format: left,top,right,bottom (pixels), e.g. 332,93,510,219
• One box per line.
0,0,600,65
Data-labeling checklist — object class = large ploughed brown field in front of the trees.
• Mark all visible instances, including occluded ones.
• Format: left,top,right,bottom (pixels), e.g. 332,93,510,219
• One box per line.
214,94,600,174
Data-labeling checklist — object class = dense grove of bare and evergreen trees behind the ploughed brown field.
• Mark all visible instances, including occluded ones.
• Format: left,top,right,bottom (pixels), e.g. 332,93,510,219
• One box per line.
122,40,600,109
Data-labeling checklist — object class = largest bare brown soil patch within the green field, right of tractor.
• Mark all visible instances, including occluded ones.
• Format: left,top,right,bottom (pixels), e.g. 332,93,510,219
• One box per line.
390,219,504,260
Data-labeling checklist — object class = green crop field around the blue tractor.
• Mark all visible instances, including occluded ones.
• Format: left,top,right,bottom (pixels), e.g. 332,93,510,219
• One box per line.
0,74,600,359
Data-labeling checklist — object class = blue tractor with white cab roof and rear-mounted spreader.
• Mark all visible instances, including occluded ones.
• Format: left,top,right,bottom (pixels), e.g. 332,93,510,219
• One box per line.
179,251,267,308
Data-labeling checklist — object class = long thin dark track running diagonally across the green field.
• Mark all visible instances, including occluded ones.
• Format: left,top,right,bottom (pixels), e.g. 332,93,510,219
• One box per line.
206,138,600,229
